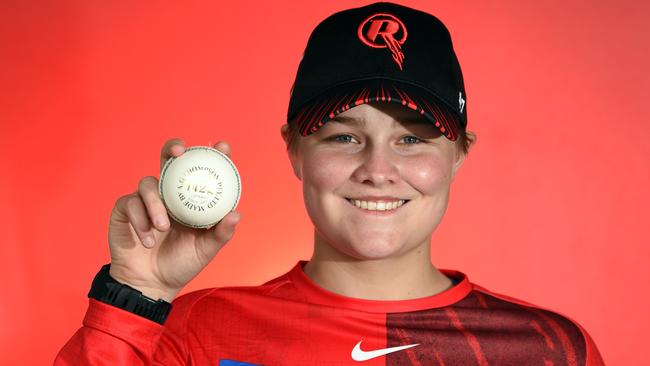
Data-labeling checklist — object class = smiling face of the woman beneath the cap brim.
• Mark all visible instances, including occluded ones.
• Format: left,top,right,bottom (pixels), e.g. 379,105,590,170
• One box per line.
283,103,464,260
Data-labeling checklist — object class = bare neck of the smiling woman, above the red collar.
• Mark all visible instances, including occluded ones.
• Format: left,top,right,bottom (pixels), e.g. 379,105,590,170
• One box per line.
304,233,452,300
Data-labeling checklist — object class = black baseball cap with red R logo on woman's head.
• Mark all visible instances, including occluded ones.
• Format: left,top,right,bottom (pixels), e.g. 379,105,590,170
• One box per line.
287,2,467,141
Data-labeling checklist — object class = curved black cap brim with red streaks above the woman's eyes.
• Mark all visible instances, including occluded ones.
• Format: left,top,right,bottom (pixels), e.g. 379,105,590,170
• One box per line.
291,81,462,141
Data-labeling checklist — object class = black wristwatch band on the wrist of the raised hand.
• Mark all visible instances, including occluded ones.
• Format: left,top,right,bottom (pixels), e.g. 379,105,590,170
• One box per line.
88,264,172,324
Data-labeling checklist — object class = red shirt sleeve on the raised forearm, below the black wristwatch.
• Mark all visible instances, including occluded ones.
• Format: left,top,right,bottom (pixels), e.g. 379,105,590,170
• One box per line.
54,290,213,366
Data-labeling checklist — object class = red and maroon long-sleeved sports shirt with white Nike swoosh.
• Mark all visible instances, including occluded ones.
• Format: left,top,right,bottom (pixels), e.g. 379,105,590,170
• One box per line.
55,261,604,366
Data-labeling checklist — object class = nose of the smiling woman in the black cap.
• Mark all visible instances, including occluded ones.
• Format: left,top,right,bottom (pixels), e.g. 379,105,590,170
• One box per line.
352,145,399,186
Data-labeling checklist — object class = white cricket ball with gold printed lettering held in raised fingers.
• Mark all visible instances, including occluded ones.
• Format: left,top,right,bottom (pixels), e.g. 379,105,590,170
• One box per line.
158,146,241,228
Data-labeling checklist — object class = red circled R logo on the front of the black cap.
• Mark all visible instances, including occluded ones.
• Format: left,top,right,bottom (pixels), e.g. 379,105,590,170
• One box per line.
357,13,408,70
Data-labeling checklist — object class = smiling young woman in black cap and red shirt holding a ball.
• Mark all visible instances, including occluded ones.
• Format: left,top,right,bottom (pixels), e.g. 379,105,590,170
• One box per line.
56,3,602,366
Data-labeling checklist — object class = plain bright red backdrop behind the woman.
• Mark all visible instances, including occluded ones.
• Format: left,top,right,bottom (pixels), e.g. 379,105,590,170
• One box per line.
0,0,650,365
